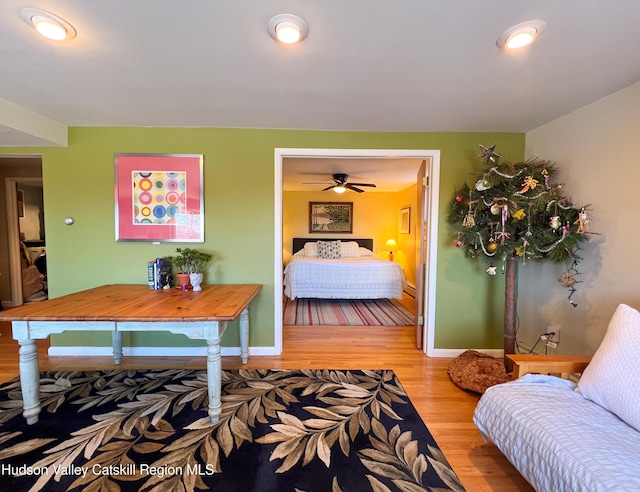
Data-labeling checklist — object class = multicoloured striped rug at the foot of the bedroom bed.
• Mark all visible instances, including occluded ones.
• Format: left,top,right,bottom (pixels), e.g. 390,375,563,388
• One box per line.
283,299,415,326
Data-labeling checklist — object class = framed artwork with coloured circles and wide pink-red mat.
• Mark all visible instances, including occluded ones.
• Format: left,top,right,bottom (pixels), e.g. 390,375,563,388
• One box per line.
114,154,204,242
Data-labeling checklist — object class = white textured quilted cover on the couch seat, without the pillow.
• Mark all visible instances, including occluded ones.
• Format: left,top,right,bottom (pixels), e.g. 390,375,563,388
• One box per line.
473,374,640,492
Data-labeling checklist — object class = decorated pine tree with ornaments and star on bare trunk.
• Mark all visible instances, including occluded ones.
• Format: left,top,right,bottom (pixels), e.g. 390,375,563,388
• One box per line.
449,145,589,369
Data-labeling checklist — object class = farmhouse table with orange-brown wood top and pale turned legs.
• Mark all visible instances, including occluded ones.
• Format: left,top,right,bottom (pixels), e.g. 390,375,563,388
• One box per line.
0,284,262,424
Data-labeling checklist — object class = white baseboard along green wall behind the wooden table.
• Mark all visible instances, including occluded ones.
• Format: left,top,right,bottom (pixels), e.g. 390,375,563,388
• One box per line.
48,346,279,357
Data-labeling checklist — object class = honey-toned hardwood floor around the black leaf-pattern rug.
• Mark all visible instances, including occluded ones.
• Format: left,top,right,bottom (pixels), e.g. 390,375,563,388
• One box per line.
0,322,533,492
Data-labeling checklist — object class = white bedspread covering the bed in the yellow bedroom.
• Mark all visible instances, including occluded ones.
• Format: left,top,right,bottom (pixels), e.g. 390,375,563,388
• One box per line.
284,254,406,299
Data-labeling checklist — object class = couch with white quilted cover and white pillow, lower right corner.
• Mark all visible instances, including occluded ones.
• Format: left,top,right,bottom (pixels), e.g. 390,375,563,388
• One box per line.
473,304,640,492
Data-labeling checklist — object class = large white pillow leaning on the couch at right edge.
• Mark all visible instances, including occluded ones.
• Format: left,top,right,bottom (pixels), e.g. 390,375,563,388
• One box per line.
578,304,640,431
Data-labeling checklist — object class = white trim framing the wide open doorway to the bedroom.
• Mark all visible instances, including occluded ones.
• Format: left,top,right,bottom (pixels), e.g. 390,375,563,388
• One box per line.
273,148,440,357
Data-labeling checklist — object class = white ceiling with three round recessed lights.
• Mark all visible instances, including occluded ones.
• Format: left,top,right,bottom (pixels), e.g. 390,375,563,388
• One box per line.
0,0,640,188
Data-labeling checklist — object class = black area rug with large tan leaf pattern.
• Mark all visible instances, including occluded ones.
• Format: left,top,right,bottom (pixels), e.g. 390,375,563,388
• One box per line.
0,369,464,492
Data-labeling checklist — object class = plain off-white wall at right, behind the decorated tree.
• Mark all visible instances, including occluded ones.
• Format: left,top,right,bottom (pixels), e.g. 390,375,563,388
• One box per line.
518,83,640,354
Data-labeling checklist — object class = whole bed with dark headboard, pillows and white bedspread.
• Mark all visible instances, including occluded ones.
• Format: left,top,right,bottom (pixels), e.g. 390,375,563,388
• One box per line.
284,238,406,299
